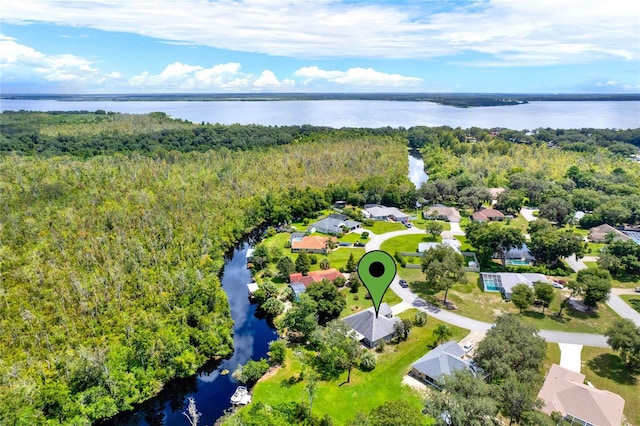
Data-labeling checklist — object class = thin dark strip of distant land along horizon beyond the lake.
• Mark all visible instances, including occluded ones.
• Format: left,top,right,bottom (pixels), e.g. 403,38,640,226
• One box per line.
0,93,640,108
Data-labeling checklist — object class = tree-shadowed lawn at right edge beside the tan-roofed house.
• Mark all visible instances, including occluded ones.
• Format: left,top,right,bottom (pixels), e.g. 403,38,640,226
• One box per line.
581,346,640,425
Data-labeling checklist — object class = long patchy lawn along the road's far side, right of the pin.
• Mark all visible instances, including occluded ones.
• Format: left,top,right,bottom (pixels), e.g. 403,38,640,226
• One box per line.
407,272,619,334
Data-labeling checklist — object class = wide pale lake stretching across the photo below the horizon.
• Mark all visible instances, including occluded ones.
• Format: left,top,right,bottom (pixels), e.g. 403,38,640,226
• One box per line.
0,99,640,130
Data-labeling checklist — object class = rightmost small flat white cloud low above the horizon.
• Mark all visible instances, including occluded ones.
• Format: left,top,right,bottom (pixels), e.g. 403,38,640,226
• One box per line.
293,66,423,88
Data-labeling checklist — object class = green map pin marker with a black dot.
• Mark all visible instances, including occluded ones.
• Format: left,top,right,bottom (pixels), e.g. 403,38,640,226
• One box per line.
358,250,397,318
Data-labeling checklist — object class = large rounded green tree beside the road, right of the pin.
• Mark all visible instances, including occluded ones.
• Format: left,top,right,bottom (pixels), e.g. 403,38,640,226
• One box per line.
422,245,464,304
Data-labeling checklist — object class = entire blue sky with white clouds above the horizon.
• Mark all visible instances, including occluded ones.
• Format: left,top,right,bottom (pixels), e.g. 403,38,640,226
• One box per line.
0,0,640,94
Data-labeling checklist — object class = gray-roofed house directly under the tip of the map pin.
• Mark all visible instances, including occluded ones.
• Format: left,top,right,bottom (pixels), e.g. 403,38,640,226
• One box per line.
342,303,400,348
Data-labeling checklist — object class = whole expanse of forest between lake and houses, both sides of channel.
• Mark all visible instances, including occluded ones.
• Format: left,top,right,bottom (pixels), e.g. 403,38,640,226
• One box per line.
0,111,640,424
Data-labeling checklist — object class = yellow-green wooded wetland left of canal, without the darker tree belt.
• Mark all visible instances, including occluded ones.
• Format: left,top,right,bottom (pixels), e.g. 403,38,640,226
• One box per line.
0,114,410,424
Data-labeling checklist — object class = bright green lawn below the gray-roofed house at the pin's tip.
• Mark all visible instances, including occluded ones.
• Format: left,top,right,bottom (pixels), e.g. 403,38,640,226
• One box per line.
253,309,467,425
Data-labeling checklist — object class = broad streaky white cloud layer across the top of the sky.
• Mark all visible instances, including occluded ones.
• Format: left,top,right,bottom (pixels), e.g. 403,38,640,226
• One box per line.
2,0,640,66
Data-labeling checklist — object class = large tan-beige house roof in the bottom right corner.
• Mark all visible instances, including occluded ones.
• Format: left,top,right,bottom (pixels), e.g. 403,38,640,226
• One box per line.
538,364,624,426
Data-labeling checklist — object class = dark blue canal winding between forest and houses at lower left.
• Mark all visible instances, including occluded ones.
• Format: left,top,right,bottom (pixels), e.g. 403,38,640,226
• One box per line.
101,243,277,426
